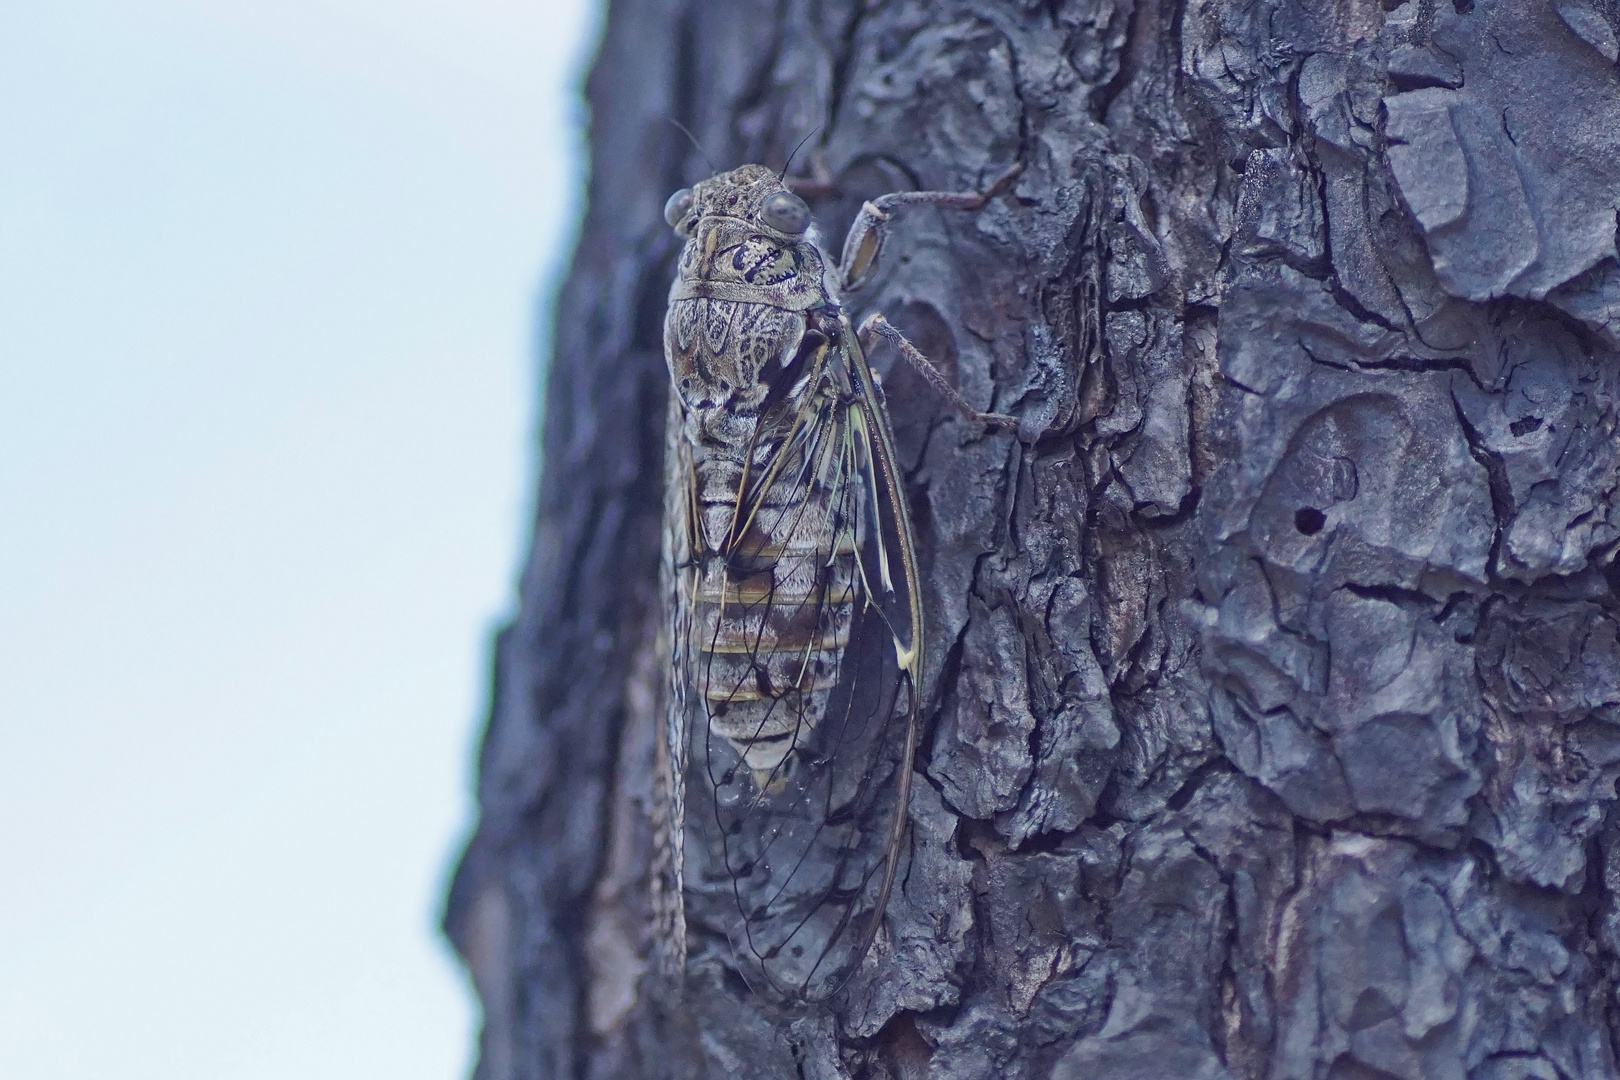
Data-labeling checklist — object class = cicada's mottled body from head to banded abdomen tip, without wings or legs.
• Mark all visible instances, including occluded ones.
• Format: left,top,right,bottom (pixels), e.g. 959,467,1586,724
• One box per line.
664,167,859,780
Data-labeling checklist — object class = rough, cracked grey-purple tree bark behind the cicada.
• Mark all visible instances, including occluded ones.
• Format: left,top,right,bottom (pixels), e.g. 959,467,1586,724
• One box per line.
447,0,1620,1080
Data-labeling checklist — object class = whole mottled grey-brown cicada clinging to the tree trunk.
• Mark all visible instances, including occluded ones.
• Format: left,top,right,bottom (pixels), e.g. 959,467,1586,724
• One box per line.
654,156,1017,1001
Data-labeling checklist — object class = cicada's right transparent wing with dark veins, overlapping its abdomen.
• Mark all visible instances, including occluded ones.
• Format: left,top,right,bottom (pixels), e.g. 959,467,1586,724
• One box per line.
692,324,919,999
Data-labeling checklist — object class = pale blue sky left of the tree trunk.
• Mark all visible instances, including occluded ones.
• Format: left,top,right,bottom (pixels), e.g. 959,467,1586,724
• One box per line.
0,0,596,1080
